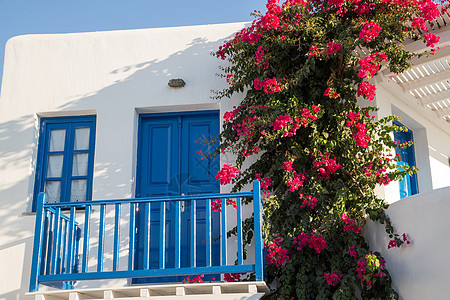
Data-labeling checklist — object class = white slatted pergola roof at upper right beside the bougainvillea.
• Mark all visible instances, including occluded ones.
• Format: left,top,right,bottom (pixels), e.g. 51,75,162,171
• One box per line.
377,7,450,134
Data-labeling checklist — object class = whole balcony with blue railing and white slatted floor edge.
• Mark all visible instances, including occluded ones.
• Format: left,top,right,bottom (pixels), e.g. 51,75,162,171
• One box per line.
29,181,267,299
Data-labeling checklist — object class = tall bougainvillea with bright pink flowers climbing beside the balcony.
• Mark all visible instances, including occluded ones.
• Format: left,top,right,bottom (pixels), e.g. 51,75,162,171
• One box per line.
210,0,442,299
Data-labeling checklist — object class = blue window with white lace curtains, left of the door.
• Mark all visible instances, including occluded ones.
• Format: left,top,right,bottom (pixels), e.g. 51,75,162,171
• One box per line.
33,116,95,211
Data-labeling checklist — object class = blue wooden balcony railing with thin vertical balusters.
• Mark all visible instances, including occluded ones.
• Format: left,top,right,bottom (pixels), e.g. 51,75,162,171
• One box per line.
30,181,263,292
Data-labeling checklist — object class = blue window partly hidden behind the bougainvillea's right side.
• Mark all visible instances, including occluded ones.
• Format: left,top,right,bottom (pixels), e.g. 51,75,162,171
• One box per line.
394,122,419,199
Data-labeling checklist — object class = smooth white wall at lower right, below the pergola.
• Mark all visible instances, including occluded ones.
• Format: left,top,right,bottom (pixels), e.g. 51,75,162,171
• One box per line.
365,187,450,300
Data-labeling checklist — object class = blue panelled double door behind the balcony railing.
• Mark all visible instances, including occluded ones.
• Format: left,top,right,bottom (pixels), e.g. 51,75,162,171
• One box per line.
134,111,220,283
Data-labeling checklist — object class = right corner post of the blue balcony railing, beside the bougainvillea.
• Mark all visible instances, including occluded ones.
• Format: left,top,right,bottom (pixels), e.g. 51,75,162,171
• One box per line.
253,180,264,280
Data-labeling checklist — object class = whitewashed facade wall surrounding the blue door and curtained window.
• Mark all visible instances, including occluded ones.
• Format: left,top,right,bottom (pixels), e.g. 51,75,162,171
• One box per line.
0,23,244,299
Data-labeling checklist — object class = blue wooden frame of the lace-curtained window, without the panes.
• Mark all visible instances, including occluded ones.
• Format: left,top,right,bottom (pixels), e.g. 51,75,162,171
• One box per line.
32,115,96,211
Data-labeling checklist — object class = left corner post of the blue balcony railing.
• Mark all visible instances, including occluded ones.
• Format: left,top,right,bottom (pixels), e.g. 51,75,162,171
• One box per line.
30,193,47,292
